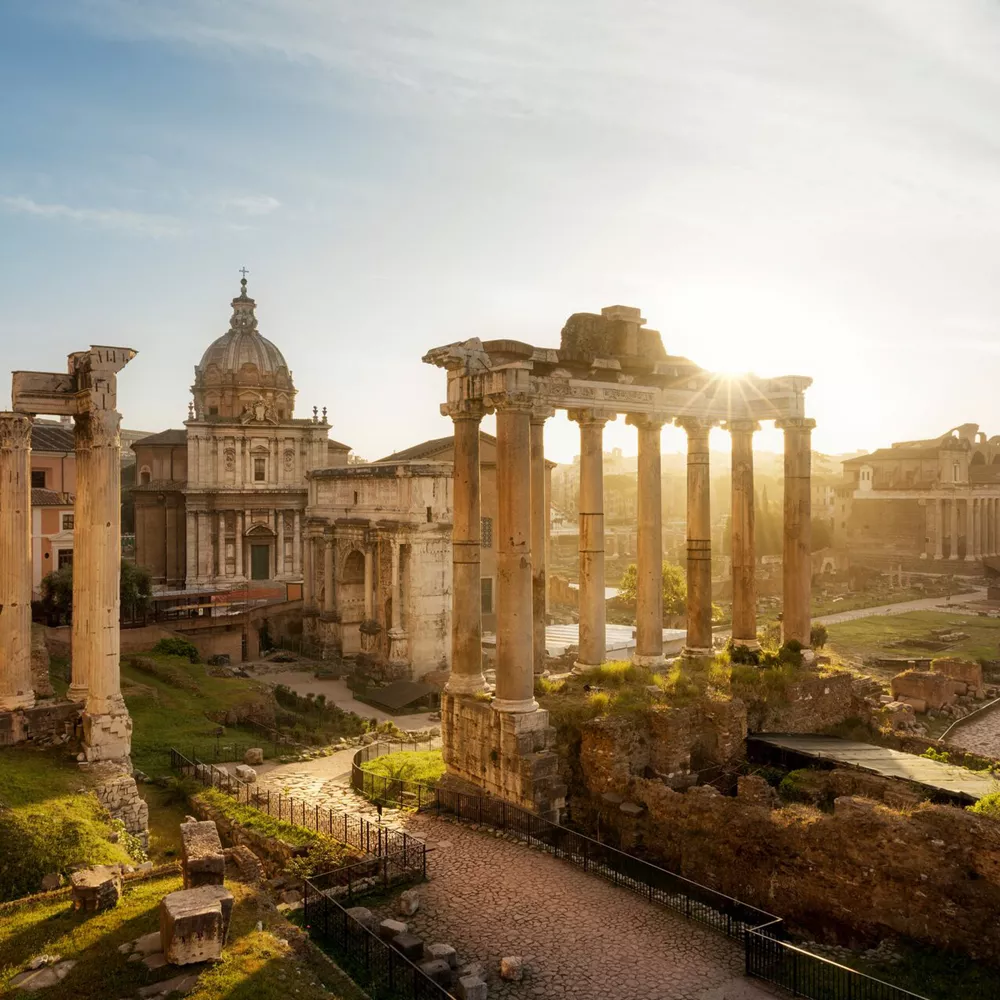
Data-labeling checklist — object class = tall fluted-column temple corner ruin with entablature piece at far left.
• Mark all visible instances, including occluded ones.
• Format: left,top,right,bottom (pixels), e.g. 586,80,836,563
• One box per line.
0,347,136,761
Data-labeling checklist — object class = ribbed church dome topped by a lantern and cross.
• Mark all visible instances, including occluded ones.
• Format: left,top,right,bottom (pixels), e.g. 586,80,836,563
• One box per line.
192,277,295,420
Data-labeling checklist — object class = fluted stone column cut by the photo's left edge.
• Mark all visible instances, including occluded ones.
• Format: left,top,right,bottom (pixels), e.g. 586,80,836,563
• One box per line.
0,413,35,711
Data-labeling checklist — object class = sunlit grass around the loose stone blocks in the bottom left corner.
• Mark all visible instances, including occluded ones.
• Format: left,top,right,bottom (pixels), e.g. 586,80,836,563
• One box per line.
0,875,361,1000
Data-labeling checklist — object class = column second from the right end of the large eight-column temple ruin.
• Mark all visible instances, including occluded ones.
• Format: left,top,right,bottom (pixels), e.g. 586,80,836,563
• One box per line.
729,420,760,649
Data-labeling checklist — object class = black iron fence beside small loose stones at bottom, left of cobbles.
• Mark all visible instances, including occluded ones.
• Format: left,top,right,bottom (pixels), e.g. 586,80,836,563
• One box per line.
303,879,451,1000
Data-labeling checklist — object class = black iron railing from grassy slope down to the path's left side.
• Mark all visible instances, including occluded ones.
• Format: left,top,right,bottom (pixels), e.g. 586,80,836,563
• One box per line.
170,749,426,866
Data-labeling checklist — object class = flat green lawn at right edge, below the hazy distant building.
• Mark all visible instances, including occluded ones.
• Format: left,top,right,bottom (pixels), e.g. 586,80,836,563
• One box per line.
827,610,1000,677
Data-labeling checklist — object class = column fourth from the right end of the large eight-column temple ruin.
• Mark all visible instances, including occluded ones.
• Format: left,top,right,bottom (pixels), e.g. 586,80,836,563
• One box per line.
626,413,666,667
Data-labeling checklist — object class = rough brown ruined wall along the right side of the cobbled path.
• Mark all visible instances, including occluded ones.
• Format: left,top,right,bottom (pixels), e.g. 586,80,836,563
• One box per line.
601,778,1000,961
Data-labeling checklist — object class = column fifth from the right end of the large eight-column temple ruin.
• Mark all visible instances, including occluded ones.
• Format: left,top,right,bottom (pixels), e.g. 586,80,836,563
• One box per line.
569,409,609,670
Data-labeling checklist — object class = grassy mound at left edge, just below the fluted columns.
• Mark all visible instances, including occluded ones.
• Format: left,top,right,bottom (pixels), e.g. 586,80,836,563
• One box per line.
0,747,131,899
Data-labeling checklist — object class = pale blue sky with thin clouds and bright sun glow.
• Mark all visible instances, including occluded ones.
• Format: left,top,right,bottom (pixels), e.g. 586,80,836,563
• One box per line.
0,0,1000,461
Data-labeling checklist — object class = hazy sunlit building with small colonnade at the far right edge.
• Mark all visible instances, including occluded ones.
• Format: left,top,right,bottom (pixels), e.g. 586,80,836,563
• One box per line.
834,424,1000,573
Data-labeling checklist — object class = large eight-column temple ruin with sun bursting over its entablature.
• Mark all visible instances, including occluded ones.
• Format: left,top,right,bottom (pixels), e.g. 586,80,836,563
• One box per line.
424,306,814,815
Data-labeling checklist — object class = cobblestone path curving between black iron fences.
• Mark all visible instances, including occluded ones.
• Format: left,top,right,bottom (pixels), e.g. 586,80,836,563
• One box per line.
254,761,784,1000
